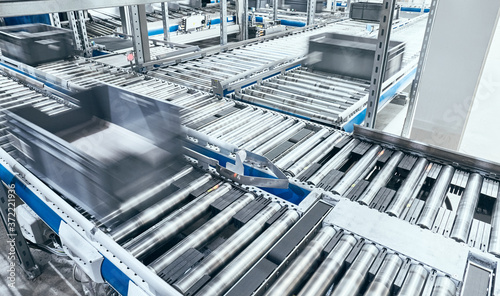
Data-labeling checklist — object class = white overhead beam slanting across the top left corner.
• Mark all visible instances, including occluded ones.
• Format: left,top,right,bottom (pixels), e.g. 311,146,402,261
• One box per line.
0,0,178,17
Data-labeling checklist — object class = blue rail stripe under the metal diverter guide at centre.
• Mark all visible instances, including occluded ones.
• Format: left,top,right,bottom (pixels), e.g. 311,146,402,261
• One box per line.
185,142,310,205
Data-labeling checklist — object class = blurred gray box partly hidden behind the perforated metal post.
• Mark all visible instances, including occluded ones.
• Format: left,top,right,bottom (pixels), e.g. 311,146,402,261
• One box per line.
307,33,405,80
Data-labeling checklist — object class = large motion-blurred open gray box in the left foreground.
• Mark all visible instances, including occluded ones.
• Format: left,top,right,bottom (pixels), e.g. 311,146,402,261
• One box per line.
6,86,183,218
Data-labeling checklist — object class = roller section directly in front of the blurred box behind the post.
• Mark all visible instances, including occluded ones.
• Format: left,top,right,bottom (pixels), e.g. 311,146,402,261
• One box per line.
235,67,370,126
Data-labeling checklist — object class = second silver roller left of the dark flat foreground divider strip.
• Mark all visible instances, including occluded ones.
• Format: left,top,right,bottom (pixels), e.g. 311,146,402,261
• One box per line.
175,202,281,293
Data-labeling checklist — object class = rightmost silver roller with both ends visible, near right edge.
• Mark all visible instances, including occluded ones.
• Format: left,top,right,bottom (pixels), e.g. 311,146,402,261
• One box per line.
450,173,483,242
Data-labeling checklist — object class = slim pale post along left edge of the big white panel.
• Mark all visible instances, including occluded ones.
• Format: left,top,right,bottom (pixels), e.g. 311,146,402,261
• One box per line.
401,0,438,137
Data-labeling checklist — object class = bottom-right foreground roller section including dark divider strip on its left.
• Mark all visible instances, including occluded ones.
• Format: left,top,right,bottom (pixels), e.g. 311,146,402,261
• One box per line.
226,202,492,296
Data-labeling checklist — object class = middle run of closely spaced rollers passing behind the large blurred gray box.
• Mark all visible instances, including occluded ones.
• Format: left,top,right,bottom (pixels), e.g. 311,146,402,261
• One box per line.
14,59,340,162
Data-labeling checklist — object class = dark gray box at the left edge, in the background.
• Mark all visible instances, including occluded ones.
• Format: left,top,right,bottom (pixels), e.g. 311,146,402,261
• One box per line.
0,24,74,66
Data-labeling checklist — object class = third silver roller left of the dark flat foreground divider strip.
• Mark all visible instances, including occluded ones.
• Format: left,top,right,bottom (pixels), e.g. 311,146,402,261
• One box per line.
149,193,255,273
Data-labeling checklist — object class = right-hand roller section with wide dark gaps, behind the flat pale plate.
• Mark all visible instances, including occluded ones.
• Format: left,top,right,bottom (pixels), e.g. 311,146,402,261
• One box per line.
294,133,499,252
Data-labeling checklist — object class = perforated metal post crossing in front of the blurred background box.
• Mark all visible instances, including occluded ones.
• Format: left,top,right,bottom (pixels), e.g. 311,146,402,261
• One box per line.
365,0,396,128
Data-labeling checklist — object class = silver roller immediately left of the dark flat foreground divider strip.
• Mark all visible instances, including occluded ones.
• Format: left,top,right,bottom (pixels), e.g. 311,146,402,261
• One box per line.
198,210,299,296
